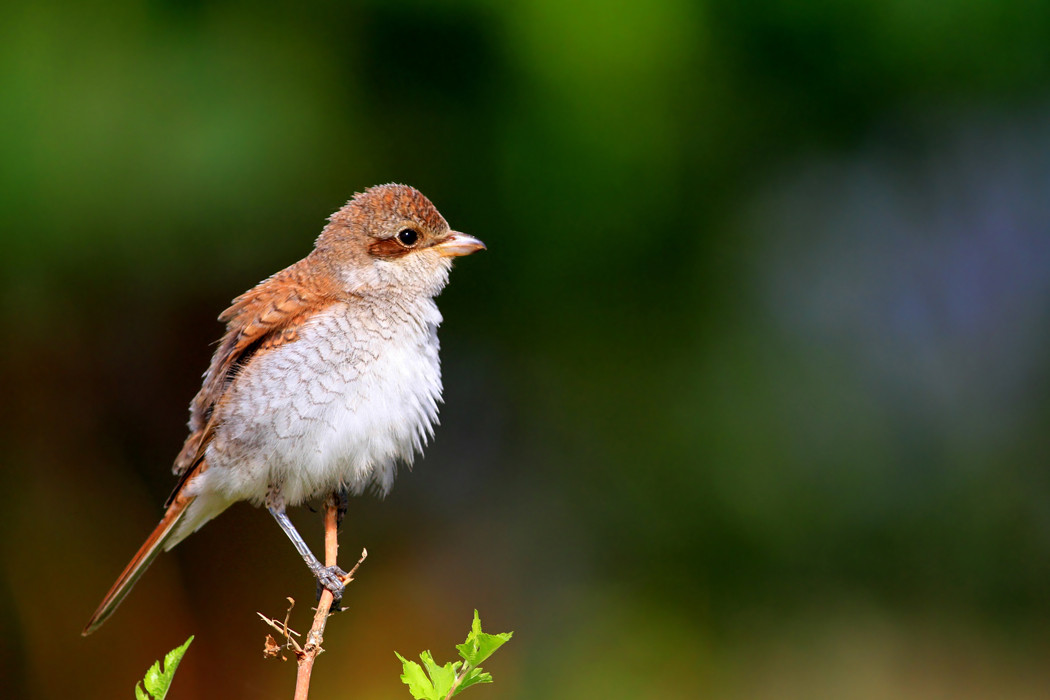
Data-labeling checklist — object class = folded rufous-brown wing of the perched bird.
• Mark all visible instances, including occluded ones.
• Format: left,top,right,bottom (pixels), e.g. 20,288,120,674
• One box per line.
169,258,339,502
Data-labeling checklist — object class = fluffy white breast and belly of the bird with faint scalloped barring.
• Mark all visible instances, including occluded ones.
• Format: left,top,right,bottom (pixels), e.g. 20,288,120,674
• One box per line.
194,298,441,505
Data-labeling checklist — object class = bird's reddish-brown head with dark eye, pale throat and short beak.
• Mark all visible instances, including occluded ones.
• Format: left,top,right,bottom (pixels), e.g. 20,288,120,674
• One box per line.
317,185,485,296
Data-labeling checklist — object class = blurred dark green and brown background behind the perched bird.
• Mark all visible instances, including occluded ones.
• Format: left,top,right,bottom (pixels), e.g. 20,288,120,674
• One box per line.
0,0,1050,700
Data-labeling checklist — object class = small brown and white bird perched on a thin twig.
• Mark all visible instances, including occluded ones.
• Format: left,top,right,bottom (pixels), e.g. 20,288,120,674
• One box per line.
83,185,485,636
